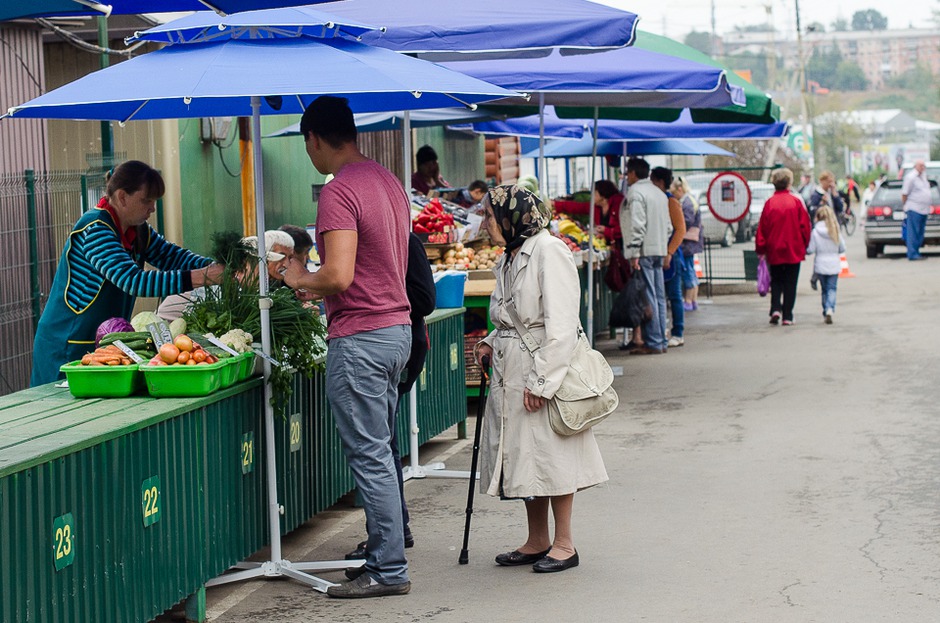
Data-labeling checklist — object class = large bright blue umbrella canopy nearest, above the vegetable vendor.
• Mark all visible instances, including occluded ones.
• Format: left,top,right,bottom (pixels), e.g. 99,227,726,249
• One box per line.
8,37,517,121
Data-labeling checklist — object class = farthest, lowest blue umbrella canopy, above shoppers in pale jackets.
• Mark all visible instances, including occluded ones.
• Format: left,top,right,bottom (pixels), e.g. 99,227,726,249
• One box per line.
522,135,734,158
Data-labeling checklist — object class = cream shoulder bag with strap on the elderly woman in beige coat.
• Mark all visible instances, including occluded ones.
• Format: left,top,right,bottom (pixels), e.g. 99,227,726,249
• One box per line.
506,300,620,436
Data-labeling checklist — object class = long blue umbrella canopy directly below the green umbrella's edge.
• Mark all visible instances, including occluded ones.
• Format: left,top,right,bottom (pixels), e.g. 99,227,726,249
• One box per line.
450,106,788,140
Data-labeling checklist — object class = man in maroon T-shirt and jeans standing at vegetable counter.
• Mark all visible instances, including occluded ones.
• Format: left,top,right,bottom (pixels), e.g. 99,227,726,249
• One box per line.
284,96,411,598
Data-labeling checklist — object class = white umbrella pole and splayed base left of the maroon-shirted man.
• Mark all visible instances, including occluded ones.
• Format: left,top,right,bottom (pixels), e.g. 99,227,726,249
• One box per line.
206,97,365,593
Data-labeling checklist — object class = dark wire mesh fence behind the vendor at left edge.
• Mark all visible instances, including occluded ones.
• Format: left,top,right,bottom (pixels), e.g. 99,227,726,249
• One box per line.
0,170,104,396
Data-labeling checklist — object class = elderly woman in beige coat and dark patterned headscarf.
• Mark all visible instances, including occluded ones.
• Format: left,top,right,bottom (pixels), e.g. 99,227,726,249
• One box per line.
476,186,607,573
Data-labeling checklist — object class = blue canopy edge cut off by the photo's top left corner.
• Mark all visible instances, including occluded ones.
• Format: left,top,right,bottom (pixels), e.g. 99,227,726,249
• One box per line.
0,0,329,22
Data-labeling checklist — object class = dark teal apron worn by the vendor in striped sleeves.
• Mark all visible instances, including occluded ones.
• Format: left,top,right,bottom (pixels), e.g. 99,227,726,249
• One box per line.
29,208,144,387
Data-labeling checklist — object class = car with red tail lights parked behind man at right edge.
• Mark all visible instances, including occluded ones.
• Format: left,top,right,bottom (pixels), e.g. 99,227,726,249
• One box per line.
865,180,940,257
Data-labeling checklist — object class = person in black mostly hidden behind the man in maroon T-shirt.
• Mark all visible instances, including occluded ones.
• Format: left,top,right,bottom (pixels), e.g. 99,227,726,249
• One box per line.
346,232,437,560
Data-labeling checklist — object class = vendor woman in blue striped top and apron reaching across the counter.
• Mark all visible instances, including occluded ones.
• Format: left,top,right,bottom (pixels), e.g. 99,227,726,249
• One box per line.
30,160,222,386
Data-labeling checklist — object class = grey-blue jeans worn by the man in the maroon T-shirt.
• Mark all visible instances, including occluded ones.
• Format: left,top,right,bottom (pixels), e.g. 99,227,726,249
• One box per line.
326,325,411,584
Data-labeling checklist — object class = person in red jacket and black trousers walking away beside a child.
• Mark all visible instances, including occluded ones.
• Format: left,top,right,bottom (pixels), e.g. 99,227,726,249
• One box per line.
755,168,812,326
